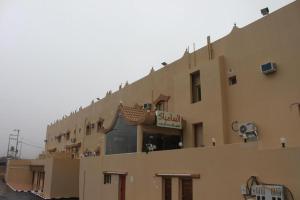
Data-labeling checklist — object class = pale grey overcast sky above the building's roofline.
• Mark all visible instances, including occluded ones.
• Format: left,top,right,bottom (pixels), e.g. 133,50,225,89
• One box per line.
0,0,293,158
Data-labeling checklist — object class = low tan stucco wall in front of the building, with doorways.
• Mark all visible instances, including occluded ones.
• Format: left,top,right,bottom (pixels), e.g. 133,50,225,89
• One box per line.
80,143,300,200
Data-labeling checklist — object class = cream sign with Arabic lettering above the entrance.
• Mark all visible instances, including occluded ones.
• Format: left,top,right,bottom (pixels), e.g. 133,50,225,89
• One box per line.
155,111,182,129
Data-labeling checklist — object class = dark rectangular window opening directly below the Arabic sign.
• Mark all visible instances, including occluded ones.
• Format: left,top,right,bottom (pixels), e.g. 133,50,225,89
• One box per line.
143,133,181,152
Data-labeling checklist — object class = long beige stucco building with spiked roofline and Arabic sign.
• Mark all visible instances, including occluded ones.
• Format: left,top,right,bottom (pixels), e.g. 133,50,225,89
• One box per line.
7,0,300,200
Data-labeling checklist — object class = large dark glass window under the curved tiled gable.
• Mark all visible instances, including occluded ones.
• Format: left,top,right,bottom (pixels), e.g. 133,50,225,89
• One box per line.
106,116,137,155
